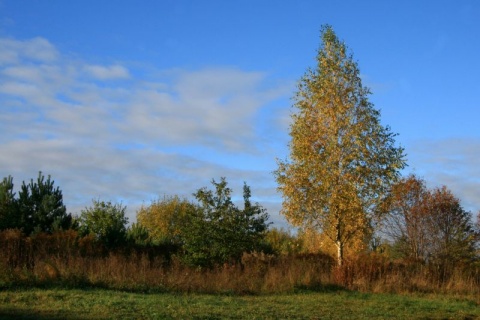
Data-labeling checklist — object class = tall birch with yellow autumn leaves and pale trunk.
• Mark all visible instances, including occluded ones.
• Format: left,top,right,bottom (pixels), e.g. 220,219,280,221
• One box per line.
275,26,405,265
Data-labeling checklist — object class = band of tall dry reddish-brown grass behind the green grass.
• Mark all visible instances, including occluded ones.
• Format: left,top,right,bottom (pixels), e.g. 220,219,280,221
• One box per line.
0,230,480,295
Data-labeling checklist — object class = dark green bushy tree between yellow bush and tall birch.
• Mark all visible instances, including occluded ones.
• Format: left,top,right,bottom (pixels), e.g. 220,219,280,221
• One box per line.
182,178,268,267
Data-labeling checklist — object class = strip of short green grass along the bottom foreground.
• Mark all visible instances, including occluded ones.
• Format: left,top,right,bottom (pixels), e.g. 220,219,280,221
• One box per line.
0,289,480,320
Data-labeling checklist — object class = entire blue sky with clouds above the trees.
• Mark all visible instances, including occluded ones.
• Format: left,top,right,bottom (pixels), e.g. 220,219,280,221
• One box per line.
0,0,480,226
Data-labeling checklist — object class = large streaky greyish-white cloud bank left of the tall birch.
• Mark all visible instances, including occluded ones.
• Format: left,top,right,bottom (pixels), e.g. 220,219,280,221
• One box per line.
0,38,289,225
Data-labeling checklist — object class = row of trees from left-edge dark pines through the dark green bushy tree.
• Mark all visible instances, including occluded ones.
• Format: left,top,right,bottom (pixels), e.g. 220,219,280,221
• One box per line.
0,172,269,267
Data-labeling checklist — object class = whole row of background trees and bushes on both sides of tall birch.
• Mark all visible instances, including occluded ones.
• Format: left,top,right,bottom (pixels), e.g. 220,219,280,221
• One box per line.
0,172,480,267
